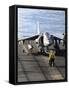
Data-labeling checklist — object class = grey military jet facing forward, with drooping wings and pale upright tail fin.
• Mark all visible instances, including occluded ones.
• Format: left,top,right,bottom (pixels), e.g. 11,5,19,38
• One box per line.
18,21,62,53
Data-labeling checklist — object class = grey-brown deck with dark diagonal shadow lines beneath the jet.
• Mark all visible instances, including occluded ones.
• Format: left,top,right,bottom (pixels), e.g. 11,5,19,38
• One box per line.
18,41,65,82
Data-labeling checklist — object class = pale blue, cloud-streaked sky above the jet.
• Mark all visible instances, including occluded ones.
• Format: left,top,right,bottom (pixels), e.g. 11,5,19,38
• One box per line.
18,8,65,39
